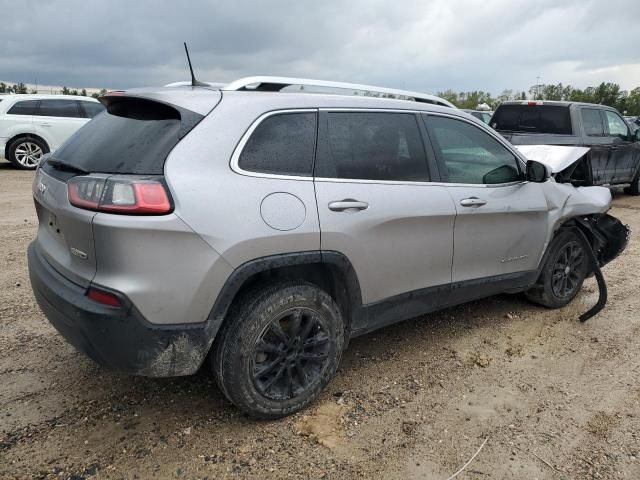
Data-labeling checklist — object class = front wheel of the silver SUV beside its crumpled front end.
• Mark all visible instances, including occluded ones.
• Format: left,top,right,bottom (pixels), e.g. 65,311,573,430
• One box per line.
525,230,590,308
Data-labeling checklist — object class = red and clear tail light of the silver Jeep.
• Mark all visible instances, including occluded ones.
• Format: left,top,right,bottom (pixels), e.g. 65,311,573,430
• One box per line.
68,176,172,215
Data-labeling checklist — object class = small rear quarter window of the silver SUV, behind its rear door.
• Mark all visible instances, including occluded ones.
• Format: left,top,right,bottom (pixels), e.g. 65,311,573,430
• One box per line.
238,112,316,177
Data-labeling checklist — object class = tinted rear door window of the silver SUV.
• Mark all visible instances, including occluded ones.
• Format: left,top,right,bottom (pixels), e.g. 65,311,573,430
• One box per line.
315,112,429,181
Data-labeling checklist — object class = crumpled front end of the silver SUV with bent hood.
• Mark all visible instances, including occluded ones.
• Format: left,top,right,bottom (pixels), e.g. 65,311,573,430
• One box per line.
517,145,631,322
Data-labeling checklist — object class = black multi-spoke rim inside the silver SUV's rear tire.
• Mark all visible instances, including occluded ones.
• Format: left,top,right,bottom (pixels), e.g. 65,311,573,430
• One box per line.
252,308,330,400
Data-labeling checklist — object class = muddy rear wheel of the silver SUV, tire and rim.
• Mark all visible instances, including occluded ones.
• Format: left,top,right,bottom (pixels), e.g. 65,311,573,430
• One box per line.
211,282,344,419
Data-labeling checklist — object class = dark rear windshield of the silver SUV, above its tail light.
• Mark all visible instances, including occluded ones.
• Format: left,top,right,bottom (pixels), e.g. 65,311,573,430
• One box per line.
52,97,202,175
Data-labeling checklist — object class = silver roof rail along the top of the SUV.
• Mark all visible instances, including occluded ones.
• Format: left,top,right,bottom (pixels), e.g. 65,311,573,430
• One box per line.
221,77,456,108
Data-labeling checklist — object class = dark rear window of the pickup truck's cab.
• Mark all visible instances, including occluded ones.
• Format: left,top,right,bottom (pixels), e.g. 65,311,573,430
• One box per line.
491,105,571,135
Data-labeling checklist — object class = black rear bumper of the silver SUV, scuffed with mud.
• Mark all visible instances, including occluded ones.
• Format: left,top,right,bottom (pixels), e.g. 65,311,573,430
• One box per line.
27,242,213,377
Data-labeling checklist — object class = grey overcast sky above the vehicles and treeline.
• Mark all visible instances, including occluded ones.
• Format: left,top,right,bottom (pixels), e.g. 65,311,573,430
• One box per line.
0,0,640,93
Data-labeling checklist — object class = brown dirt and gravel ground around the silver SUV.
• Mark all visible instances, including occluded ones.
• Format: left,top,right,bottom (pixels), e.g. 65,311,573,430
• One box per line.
0,163,640,480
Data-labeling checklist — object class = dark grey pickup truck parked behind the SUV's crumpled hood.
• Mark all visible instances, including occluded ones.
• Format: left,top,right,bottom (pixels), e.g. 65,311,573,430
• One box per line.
489,101,640,195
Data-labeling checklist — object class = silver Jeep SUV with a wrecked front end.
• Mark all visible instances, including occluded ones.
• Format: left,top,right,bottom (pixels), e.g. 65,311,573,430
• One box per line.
28,77,628,418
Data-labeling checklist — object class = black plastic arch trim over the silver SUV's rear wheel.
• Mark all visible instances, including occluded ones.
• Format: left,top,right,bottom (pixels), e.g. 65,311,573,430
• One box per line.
209,251,362,348
